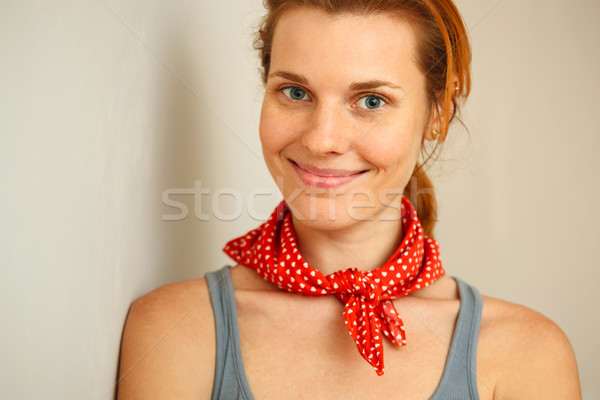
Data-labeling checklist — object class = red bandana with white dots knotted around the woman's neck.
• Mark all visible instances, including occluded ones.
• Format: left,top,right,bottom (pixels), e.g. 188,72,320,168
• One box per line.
223,197,444,375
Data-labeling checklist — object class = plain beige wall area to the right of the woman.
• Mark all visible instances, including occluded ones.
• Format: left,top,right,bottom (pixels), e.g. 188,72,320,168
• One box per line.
438,0,600,400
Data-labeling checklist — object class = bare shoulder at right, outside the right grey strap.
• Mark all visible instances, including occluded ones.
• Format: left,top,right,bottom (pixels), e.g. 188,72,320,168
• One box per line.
478,296,581,400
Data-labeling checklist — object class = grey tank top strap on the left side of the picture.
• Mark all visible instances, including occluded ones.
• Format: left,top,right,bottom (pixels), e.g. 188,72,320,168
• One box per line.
206,266,254,400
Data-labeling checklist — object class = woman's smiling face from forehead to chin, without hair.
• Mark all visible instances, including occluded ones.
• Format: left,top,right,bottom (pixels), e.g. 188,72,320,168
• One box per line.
260,8,432,229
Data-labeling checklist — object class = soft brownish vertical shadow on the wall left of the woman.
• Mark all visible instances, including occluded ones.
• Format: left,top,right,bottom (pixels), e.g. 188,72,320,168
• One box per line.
113,27,214,399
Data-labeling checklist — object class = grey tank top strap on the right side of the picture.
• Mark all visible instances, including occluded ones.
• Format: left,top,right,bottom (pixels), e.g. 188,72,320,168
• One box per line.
431,278,483,400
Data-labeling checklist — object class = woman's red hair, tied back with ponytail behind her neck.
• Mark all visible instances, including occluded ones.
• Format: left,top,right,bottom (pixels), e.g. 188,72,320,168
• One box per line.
255,0,471,237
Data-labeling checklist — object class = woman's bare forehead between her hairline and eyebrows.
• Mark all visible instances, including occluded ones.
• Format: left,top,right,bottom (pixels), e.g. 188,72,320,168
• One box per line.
270,7,421,85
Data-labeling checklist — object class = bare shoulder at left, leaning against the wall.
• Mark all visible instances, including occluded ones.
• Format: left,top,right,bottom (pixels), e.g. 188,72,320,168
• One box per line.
118,279,215,400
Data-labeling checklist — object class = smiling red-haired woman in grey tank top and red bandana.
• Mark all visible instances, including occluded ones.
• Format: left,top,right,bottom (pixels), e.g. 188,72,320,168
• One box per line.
118,0,581,400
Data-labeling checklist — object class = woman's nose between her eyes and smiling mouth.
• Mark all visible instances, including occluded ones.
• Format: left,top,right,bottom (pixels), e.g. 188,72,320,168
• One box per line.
302,103,352,155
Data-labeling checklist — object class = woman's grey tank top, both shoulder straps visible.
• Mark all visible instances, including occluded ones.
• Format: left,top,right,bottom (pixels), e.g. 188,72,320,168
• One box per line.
206,266,483,400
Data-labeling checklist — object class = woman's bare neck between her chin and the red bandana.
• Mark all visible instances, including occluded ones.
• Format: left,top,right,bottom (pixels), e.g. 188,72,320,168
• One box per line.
293,219,404,275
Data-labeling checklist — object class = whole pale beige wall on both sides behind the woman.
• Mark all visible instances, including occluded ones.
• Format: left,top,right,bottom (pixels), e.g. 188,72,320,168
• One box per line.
0,0,600,400
